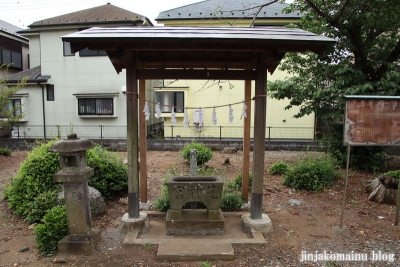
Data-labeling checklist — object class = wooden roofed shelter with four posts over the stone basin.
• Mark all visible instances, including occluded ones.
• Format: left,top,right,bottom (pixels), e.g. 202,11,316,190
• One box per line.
62,27,335,220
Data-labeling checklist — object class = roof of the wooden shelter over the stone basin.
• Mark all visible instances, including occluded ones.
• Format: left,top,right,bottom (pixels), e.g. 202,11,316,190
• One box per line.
62,27,335,74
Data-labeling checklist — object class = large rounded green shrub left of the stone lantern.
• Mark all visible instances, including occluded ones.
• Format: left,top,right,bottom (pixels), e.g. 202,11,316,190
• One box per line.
4,141,60,223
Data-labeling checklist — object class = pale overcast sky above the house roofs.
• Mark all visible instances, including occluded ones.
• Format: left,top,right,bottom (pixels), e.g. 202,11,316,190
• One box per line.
0,0,202,29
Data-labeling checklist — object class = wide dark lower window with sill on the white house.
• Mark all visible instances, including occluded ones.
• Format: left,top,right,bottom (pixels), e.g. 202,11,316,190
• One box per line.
78,98,114,115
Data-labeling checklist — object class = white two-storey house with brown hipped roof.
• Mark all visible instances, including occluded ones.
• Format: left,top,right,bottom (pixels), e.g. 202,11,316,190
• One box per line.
8,3,160,138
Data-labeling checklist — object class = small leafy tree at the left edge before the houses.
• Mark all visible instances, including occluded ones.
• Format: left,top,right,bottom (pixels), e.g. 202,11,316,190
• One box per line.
0,65,27,126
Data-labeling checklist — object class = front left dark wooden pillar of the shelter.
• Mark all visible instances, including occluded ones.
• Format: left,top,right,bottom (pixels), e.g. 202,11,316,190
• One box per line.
126,63,140,218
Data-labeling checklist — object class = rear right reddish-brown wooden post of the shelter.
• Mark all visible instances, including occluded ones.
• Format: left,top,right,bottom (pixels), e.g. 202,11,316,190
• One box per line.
242,80,251,203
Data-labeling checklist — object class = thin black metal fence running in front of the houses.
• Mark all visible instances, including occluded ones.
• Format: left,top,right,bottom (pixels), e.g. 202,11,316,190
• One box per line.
3,122,315,140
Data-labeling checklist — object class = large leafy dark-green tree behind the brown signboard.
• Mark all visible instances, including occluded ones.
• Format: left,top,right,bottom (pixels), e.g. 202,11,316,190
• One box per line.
268,0,400,169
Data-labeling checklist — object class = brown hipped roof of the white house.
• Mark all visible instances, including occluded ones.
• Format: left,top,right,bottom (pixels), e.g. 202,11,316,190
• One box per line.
28,3,151,28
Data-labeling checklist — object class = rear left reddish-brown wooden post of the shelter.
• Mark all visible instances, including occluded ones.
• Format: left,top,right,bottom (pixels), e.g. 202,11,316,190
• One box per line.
139,80,147,203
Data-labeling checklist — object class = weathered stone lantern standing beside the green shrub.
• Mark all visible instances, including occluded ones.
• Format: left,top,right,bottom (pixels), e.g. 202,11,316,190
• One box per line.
49,133,101,254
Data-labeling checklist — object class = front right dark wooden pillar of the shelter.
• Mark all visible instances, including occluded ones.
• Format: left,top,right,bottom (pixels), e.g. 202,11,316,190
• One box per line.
250,65,267,220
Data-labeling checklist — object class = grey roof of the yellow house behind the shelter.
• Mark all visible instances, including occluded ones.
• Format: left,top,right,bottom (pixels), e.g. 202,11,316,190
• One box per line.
156,0,301,20
